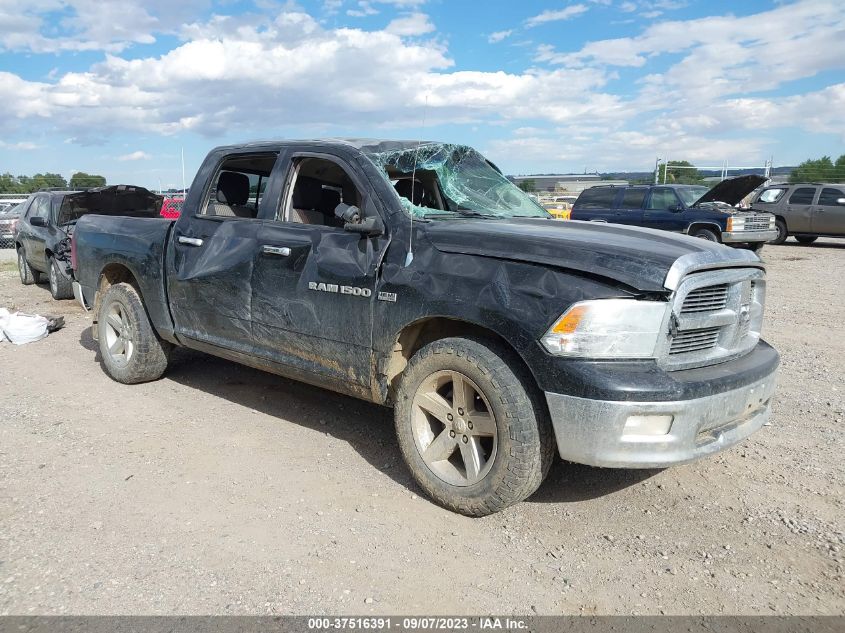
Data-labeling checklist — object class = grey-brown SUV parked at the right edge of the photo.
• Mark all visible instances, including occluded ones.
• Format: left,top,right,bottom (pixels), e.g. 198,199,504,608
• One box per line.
751,183,845,244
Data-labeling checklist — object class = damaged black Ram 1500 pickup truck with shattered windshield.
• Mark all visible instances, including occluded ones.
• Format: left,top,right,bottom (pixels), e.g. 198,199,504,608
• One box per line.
73,140,778,516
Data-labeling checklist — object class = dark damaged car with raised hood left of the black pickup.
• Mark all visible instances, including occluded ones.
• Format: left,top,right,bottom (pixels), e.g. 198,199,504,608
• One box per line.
13,185,162,299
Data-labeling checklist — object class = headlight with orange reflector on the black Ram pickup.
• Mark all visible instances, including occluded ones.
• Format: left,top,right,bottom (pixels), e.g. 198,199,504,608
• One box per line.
540,299,669,358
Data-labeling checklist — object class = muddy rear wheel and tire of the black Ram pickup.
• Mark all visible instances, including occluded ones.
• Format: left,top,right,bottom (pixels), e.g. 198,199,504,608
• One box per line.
96,283,171,385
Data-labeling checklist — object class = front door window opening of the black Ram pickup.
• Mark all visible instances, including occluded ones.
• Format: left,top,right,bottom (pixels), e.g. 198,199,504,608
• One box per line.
277,157,362,228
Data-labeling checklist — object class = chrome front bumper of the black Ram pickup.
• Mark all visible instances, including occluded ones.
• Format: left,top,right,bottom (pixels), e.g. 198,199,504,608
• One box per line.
546,370,777,468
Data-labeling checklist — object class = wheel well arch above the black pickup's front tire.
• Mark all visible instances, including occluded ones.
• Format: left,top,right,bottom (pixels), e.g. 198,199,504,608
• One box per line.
382,317,533,402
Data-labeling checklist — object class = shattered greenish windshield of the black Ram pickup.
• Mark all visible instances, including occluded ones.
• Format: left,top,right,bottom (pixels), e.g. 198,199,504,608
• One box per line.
367,143,550,218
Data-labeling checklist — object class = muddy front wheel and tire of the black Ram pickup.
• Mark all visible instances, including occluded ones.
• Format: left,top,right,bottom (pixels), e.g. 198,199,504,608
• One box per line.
394,338,555,516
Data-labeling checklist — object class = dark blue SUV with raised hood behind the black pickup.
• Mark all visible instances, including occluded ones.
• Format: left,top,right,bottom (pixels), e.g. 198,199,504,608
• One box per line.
571,176,777,251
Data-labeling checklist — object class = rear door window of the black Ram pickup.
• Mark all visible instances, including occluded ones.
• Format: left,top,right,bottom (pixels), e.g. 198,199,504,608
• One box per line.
200,152,278,218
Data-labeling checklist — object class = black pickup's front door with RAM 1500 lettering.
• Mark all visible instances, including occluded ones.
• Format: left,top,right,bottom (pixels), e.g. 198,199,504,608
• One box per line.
246,146,388,392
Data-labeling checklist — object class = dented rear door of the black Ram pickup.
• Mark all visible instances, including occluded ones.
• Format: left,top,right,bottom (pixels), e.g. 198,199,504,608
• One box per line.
166,151,278,353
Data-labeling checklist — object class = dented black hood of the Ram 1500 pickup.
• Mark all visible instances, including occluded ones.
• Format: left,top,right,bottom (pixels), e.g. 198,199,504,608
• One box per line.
425,218,756,292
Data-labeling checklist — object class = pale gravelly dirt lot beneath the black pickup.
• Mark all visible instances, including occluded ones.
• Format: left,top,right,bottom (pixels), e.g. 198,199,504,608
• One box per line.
0,240,845,614
